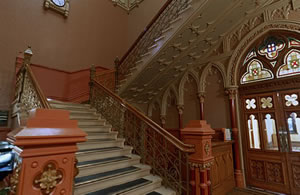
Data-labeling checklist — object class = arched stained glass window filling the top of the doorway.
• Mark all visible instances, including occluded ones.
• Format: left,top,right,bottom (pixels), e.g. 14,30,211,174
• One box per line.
240,32,300,84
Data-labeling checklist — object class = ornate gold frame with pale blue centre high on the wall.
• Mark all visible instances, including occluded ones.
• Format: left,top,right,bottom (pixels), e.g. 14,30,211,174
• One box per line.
44,0,70,17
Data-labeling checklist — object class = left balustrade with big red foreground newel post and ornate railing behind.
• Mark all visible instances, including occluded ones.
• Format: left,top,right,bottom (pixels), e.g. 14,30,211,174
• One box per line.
7,48,86,195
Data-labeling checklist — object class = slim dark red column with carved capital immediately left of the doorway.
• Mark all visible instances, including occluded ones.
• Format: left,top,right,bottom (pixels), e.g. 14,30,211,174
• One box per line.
226,88,245,188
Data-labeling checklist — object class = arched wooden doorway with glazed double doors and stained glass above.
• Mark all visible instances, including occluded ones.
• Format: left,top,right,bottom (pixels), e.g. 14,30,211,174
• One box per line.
239,31,300,195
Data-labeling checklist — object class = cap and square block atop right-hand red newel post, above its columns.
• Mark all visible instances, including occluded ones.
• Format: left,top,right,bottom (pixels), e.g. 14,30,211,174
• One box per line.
180,120,215,168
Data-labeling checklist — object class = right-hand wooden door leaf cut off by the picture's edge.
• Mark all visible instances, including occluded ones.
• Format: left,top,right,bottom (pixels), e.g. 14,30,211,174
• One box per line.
278,90,300,194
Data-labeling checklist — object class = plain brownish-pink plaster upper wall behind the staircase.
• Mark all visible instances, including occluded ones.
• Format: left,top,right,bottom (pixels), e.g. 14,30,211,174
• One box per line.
0,0,165,109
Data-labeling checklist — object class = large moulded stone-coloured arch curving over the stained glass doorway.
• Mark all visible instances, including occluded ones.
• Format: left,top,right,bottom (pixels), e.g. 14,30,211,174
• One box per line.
226,20,300,86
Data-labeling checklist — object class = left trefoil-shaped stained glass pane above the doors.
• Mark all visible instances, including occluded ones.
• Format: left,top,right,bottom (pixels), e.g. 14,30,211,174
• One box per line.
241,59,274,84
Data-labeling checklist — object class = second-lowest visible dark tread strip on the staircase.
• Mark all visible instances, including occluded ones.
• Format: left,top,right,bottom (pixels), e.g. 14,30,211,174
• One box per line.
87,178,151,195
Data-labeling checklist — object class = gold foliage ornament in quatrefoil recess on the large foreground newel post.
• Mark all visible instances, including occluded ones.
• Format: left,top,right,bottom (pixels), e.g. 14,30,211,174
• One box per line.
33,163,63,195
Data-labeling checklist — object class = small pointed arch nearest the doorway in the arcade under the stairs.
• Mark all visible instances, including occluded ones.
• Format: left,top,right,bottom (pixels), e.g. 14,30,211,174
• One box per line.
199,62,226,92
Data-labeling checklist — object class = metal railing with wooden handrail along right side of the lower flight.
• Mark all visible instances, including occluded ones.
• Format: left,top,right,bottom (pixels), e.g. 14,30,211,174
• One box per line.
90,79,195,194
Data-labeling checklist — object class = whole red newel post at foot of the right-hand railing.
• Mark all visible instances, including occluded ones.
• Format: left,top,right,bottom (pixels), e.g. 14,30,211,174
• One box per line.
181,120,215,195
